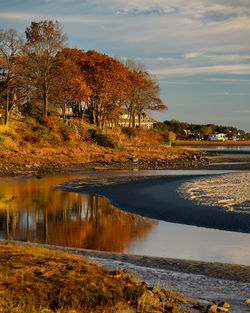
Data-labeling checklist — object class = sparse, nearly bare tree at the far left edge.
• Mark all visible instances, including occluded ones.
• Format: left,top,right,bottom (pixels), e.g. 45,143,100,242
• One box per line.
0,29,23,124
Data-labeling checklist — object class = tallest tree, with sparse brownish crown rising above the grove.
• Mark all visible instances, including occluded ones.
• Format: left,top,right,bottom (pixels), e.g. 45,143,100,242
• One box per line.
25,20,67,116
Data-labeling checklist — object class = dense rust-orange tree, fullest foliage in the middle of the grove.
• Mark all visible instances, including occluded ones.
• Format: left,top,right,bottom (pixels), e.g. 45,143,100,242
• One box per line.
81,50,129,127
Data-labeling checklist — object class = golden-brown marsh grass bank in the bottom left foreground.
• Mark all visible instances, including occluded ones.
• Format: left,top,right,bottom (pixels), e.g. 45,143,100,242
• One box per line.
0,244,195,313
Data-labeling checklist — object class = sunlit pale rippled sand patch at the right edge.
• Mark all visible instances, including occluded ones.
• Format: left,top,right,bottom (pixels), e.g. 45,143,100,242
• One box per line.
178,172,250,213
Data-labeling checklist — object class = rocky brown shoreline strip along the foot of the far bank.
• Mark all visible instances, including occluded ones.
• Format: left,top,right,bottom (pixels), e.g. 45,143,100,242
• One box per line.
0,148,250,177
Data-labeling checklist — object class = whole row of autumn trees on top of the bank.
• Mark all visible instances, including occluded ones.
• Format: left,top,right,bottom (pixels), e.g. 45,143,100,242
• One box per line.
0,20,167,127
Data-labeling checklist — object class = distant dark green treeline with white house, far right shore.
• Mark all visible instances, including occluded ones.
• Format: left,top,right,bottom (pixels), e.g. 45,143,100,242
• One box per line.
155,120,250,140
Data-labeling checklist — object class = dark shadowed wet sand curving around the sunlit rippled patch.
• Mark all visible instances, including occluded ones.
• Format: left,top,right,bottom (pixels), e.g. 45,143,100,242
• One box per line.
58,175,250,233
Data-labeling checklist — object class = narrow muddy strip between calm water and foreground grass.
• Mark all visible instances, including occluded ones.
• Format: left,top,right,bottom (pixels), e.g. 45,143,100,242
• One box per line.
0,239,250,283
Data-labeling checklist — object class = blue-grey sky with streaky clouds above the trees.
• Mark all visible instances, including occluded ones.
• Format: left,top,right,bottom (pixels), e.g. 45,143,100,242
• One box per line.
0,0,250,132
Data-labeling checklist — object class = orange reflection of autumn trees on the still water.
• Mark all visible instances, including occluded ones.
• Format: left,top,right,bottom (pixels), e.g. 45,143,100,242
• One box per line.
0,176,158,252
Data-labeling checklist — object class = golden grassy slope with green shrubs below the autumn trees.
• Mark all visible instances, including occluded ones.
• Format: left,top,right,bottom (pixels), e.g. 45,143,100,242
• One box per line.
0,113,207,176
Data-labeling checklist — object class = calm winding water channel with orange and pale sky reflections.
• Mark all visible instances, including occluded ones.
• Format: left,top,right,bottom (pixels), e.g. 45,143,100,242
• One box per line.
0,170,250,265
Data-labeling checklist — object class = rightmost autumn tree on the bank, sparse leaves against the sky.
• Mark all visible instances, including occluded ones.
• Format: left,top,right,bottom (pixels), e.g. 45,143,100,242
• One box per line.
125,59,167,128
